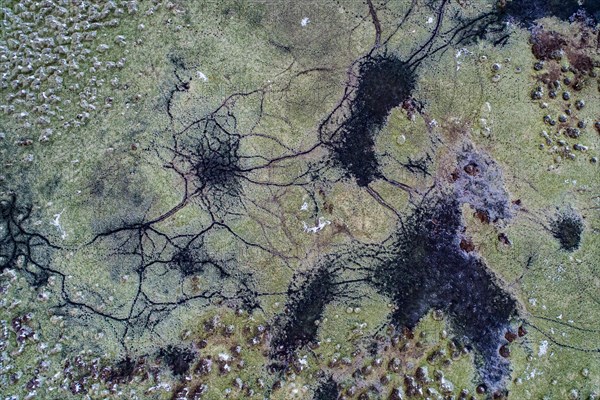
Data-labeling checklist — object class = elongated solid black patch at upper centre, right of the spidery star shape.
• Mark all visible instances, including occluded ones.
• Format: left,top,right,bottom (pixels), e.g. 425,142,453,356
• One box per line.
332,55,415,186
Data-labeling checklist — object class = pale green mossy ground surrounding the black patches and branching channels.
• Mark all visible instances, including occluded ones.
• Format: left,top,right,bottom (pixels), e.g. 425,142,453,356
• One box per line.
0,1,600,399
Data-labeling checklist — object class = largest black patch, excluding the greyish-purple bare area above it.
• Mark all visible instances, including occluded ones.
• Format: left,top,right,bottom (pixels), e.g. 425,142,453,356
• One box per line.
372,196,517,387
